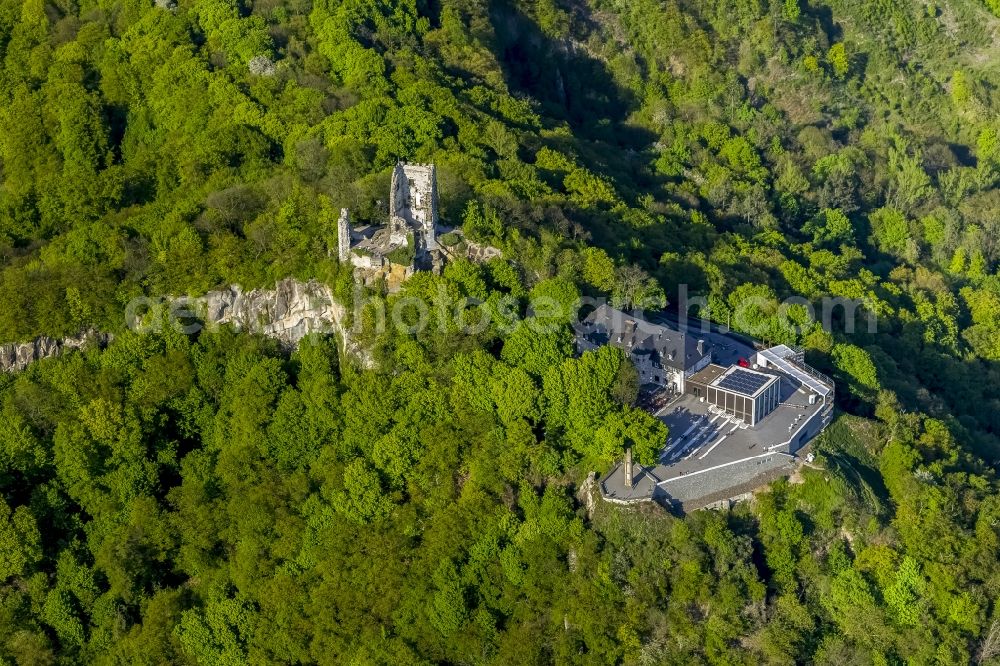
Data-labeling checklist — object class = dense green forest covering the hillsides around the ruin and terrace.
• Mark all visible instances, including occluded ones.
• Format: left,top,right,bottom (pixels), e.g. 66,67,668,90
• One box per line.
0,0,1000,665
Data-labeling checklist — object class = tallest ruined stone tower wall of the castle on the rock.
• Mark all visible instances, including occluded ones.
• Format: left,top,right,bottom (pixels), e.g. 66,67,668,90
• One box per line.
389,162,438,254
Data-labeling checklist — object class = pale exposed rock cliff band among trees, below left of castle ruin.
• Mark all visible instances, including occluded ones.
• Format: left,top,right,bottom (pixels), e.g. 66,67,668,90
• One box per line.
0,279,371,372
